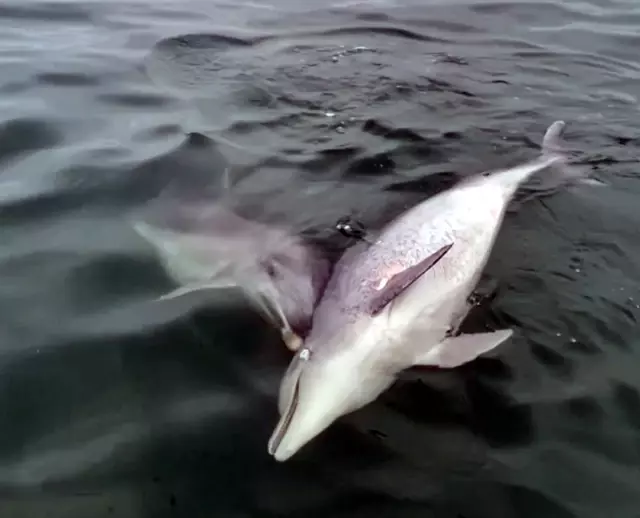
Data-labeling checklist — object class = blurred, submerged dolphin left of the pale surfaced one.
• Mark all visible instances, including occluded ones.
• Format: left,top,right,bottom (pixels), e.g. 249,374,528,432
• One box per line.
132,201,329,351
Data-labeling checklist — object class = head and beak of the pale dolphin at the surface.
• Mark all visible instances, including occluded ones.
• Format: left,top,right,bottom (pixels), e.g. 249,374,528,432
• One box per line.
268,326,394,462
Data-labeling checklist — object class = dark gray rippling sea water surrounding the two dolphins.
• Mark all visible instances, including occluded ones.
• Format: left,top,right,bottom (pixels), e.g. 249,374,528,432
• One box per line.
0,0,640,518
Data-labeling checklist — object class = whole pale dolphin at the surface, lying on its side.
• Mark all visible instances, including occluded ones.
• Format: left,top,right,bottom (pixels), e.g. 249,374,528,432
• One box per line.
268,121,596,462
